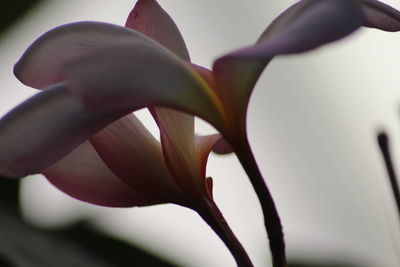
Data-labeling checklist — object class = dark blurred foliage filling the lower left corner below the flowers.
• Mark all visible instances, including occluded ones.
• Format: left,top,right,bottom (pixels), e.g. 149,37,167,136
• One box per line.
0,177,176,267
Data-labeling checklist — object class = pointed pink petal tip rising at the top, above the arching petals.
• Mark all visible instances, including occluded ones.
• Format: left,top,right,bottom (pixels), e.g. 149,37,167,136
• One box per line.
125,0,190,61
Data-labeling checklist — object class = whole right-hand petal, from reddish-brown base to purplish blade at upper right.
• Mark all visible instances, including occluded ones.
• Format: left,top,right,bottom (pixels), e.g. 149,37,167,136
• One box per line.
213,0,363,138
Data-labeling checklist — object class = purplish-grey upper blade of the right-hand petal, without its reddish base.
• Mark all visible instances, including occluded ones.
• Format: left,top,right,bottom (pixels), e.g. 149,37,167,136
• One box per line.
239,0,364,58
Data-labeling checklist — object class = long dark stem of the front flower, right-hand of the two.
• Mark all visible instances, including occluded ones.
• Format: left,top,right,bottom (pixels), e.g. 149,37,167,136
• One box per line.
233,136,287,267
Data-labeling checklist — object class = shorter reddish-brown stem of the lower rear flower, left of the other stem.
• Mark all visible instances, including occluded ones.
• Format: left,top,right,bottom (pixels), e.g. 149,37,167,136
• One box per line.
196,199,253,267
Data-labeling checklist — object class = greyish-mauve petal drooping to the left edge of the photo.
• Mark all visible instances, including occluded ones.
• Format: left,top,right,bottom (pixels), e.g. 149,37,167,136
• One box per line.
0,84,125,177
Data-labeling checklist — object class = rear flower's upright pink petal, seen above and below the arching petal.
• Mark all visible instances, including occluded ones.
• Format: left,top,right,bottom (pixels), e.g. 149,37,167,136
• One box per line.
126,0,205,202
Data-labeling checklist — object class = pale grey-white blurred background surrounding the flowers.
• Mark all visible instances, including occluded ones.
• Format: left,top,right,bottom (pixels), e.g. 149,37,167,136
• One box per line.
0,0,400,267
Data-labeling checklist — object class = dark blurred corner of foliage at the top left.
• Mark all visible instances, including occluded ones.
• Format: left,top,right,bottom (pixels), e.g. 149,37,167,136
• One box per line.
0,0,41,34
